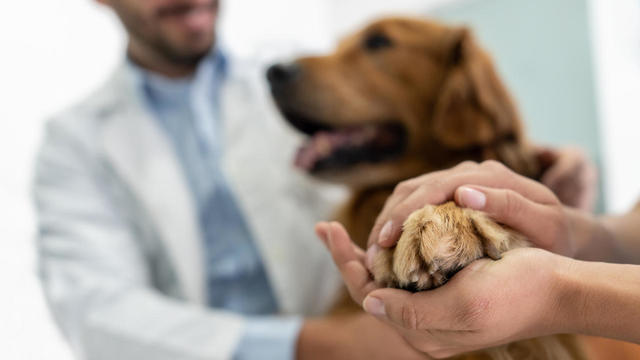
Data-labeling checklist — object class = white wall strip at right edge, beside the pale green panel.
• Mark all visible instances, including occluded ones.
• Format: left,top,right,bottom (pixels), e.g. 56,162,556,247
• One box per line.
590,0,640,213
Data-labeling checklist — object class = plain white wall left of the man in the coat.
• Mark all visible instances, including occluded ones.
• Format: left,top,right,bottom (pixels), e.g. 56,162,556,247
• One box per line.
0,0,123,360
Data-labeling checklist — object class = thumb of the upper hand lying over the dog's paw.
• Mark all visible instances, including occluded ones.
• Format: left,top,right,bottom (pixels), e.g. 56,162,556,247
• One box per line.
455,185,563,249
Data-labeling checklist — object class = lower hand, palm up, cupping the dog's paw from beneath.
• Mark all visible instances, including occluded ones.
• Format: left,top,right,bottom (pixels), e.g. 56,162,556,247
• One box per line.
316,223,571,358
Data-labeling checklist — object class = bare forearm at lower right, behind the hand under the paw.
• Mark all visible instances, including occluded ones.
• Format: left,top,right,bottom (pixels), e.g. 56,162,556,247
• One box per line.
556,259,640,343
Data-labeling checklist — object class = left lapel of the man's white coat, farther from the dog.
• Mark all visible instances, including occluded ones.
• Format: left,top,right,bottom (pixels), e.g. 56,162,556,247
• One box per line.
102,66,205,303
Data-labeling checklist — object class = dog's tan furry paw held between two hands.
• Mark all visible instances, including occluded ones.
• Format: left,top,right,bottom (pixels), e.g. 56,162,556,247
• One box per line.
371,202,528,291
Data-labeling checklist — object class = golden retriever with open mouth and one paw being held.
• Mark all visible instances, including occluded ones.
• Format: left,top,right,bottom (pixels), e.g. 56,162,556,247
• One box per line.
267,18,583,359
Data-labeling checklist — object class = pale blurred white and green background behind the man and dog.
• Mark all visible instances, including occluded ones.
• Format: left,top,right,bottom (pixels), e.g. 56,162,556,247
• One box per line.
0,0,640,359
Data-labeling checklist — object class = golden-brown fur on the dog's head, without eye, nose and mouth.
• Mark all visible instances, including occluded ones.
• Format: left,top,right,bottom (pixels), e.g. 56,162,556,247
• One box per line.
284,18,540,188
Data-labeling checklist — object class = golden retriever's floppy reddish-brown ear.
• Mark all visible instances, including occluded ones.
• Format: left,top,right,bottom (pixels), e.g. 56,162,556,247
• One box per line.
432,28,519,149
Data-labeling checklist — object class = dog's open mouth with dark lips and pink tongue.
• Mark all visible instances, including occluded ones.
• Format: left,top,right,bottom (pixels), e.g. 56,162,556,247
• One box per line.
284,113,407,173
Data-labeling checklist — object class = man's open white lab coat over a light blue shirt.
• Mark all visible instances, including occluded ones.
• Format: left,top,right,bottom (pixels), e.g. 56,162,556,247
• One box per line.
34,54,343,360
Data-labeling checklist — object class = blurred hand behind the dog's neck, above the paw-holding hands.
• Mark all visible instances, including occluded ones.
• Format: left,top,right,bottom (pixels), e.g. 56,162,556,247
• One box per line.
537,147,598,212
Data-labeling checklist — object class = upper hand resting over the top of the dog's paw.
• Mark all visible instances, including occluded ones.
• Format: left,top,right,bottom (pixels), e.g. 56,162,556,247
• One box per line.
368,161,577,258
